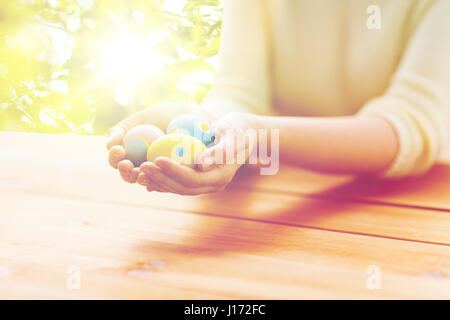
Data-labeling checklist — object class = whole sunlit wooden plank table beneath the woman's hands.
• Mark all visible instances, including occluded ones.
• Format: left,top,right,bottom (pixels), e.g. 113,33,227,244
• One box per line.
0,133,450,299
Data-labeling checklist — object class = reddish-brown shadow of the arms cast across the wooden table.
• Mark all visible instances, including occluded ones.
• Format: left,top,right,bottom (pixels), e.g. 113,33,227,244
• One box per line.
139,166,450,258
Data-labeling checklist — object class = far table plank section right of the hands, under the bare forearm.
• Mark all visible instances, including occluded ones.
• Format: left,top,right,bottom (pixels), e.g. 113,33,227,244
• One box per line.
235,164,450,212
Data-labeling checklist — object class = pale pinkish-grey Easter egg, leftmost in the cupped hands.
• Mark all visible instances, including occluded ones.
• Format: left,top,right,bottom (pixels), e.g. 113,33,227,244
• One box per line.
123,124,164,167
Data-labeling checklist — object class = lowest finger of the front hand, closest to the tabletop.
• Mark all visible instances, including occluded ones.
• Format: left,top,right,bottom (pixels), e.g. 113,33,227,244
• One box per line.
141,164,223,195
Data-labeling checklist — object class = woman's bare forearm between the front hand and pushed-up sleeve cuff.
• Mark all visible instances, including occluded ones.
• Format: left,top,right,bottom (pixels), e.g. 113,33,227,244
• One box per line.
256,116,398,174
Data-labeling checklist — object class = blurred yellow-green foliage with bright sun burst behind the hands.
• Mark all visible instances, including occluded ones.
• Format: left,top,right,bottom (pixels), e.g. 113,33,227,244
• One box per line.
0,0,222,134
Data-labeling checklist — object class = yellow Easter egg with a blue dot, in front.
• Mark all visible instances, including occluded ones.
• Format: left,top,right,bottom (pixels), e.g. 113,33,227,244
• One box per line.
147,133,206,166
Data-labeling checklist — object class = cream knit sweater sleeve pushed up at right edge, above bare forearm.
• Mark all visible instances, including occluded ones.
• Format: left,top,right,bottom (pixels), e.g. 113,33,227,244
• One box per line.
359,0,450,178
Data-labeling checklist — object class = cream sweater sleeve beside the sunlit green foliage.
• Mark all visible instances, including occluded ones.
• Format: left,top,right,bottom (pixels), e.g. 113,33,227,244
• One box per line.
202,0,271,116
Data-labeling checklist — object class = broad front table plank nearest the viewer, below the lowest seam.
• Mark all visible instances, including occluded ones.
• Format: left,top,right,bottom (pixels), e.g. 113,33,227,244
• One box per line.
0,193,450,299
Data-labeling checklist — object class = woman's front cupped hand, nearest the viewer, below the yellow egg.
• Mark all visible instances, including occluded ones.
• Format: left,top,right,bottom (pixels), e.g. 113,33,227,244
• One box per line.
137,113,257,195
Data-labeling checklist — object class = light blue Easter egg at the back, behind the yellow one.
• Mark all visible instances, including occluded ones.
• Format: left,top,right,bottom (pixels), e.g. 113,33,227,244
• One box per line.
167,114,214,146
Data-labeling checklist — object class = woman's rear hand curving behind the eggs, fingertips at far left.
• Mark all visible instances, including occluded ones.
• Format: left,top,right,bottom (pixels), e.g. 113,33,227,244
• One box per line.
106,103,211,183
